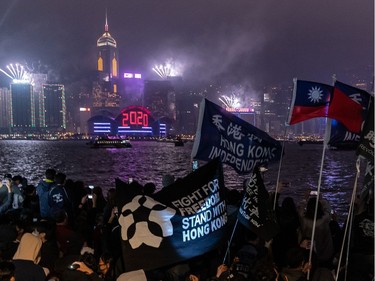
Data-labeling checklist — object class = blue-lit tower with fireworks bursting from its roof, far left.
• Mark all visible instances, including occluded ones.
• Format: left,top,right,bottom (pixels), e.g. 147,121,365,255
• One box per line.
10,83,36,133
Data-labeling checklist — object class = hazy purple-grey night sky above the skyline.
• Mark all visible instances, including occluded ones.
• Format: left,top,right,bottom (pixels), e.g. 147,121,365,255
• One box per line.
0,0,374,89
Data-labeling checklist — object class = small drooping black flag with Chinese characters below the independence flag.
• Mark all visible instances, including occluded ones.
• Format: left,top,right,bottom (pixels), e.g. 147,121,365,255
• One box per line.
237,167,279,241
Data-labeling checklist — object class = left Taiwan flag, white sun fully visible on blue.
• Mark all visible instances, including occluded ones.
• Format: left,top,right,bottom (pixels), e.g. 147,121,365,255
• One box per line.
288,80,333,125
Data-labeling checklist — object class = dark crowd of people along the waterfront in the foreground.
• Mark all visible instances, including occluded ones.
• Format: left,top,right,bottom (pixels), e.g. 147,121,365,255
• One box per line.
0,169,374,281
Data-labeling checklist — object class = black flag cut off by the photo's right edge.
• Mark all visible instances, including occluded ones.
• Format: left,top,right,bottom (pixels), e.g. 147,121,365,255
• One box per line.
357,97,375,162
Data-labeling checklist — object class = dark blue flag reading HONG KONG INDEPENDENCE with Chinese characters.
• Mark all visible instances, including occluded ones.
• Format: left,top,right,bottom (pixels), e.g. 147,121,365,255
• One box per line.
191,99,281,174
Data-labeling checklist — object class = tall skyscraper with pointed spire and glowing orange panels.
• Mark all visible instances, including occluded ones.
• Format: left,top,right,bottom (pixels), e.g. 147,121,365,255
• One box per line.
92,12,120,111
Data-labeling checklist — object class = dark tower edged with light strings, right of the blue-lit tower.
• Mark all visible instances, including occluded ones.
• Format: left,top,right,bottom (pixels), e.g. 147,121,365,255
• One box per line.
39,84,66,132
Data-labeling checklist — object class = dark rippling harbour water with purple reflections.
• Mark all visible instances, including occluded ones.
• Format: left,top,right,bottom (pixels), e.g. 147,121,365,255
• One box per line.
0,140,365,224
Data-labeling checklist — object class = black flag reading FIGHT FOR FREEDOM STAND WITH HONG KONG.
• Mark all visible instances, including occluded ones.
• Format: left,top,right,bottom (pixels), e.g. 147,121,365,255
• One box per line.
116,159,227,271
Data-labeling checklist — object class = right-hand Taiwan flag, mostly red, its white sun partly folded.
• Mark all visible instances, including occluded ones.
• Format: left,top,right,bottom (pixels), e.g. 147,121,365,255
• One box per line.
327,81,370,133
